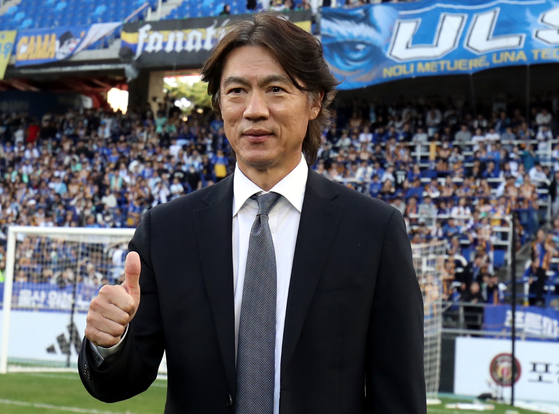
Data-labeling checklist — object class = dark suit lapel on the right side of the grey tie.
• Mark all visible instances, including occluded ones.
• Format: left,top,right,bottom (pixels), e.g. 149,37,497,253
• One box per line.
281,169,343,375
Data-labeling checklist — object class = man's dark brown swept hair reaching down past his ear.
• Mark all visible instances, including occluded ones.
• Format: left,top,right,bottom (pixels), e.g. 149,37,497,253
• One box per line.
202,12,339,165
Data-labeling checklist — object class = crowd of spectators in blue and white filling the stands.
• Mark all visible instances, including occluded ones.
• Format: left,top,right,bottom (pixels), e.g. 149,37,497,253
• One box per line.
0,94,559,303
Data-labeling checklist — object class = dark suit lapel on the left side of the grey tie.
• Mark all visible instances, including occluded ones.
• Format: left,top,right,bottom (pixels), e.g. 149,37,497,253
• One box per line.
194,176,236,395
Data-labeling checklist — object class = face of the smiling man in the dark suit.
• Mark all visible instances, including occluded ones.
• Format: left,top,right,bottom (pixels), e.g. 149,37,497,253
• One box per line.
220,46,319,174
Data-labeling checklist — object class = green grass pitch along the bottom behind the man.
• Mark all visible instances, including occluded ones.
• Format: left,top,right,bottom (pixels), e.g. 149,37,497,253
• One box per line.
0,373,544,414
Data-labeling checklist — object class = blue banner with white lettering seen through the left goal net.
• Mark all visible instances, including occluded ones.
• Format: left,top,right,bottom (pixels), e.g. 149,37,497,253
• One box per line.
0,282,101,312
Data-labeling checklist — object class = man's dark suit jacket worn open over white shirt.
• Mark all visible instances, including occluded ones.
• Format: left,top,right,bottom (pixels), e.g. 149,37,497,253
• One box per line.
79,170,426,414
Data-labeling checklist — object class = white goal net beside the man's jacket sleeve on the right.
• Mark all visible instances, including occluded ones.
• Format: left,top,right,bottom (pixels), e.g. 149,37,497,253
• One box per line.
412,241,446,403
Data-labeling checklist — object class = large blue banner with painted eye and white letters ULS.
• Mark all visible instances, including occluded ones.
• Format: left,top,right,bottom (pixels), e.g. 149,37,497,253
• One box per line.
320,0,559,89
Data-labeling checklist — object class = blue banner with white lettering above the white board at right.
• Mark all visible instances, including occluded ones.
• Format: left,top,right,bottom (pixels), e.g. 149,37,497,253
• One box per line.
483,305,559,341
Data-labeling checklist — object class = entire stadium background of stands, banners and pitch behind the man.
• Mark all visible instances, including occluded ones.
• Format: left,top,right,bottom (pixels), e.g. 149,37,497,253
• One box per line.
0,0,559,414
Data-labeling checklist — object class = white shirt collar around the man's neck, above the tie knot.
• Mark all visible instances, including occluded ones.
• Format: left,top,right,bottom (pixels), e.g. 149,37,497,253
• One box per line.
233,155,309,217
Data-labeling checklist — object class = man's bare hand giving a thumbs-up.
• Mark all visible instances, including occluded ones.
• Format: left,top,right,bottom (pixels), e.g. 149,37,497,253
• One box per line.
85,252,141,348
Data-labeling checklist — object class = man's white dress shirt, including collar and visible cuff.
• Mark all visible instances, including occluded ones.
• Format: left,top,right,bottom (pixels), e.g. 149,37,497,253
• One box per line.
92,155,309,414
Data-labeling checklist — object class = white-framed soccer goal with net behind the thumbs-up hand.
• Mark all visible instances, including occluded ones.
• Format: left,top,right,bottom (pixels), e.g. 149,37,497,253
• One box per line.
0,226,134,373
